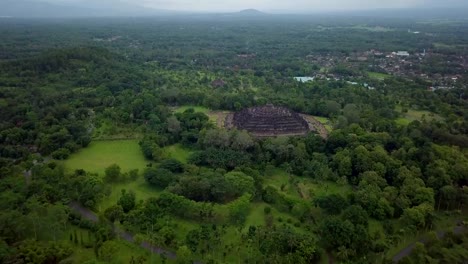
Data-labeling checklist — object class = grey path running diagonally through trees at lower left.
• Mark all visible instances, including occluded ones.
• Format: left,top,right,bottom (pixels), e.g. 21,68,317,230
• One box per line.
70,202,176,259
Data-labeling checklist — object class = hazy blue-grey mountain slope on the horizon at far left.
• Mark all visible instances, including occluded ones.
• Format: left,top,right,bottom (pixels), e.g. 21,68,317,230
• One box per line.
0,0,175,18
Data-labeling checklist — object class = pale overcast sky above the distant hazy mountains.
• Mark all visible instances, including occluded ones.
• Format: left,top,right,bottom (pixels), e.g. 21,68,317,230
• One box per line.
33,0,468,12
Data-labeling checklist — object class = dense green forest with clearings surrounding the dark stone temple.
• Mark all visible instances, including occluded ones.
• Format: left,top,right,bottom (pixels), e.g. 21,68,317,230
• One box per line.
0,16,468,264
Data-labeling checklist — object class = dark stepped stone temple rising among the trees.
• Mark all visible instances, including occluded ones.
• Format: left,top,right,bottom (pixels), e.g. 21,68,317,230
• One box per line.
225,104,314,137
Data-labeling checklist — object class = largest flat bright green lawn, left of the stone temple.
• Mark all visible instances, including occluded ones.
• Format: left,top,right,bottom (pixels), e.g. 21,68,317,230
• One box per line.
65,139,148,175
